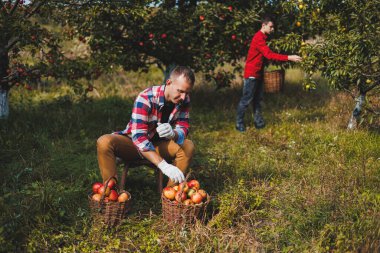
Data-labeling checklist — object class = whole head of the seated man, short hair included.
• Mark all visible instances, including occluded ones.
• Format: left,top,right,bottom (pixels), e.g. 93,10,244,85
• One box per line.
165,66,195,104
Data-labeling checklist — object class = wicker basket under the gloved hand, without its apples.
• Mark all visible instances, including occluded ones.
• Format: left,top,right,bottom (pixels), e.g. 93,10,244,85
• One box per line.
161,194,210,226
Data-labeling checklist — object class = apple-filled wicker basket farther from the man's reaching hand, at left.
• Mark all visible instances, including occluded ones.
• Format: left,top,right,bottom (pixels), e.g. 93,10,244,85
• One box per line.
88,177,131,227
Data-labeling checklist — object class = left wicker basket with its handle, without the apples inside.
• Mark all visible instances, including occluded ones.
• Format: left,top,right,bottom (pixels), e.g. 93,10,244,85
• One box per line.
88,179,131,227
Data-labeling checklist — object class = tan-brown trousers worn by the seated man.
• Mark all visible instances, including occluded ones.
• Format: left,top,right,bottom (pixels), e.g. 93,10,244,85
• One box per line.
97,134,194,186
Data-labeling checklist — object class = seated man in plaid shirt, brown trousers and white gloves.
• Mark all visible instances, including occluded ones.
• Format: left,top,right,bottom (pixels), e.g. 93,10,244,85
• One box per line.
97,66,195,185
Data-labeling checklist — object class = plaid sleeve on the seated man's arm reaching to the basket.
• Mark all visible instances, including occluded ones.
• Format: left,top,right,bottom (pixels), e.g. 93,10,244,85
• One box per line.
131,93,155,152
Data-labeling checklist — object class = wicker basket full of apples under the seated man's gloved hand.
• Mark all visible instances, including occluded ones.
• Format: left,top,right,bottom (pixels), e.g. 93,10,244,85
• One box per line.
161,175,210,226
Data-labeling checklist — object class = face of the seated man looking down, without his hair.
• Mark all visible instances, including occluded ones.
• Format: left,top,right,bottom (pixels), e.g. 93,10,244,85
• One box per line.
165,75,193,104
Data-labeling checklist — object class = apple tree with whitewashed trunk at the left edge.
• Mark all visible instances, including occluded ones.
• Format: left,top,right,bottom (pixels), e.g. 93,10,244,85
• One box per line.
0,0,96,119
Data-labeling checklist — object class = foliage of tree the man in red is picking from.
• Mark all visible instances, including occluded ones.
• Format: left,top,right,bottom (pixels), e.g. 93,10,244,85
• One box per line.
272,0,380,129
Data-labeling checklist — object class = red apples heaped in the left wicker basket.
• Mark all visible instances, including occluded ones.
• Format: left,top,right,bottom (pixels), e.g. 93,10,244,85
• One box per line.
92,179,129,202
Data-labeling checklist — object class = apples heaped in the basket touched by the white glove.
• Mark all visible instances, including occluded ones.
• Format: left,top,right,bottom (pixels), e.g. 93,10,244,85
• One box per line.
162,180,207,206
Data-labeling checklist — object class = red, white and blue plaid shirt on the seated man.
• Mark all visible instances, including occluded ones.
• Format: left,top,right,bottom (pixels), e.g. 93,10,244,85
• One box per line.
116,85,190,152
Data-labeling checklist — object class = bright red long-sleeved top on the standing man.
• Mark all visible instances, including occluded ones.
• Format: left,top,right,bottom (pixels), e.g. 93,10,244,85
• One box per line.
244,31,288,78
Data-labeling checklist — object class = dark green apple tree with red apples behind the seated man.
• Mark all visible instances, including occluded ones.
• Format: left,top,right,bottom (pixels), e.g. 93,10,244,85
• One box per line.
62,1,261,89
